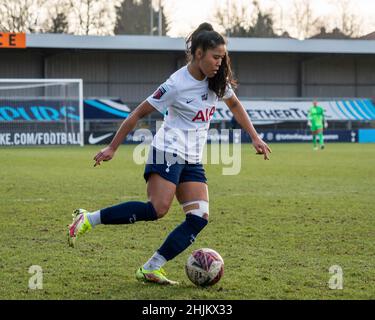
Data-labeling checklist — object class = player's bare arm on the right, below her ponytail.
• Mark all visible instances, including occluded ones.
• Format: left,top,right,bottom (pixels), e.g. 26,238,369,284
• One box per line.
224,94,272,160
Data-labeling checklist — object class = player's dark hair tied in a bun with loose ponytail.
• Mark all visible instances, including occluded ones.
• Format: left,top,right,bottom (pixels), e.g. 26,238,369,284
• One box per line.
186,22,237,98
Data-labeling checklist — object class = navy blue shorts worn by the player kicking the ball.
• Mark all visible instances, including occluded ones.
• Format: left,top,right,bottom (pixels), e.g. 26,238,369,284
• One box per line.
143,146,207,186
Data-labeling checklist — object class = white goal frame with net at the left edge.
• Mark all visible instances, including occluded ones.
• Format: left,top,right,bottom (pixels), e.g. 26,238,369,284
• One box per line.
0,79,84,147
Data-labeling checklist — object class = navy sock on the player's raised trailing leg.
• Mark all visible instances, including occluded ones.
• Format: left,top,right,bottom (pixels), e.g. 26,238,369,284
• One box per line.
100,201,157,224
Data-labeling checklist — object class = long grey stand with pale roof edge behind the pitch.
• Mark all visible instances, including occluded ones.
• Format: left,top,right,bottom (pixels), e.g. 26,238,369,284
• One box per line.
0,34,375,144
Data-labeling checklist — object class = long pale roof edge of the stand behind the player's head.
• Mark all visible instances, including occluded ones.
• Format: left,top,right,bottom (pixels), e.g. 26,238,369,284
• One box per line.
26,34,375,54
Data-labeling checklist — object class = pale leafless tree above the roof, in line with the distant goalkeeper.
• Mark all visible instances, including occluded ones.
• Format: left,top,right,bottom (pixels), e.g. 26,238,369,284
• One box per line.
291,0,324,39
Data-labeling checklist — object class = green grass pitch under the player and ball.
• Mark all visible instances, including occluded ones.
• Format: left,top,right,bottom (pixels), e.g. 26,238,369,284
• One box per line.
0,144,375,300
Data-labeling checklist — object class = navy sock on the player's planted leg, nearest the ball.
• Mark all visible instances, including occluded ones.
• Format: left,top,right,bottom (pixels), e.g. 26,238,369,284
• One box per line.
158,214,208,261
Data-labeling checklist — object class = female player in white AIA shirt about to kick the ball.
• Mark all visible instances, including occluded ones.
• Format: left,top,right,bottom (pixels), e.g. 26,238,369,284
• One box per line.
68,23,271,284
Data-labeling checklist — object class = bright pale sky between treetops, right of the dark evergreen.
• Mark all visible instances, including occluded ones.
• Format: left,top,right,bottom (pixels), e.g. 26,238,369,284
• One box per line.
163,0,375,37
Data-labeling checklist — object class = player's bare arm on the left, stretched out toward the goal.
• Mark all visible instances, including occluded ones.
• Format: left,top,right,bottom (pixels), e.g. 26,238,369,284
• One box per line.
94,100,156,167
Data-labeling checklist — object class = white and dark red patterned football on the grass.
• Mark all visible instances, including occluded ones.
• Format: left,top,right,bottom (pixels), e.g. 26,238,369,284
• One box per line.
185,248,224,287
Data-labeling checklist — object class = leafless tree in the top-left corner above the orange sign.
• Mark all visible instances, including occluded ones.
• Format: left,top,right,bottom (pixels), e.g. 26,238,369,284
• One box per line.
0,0,48,32
